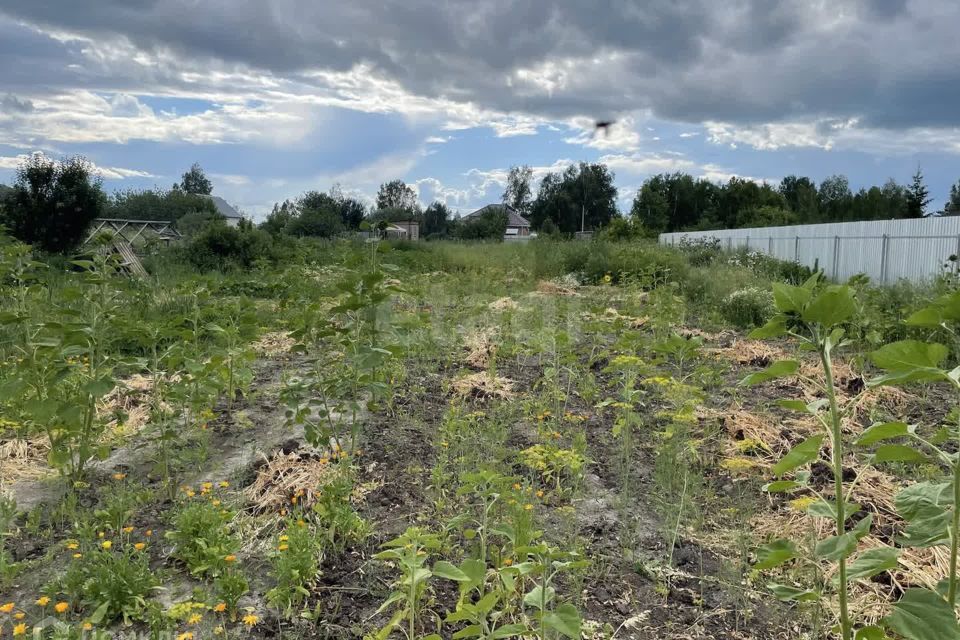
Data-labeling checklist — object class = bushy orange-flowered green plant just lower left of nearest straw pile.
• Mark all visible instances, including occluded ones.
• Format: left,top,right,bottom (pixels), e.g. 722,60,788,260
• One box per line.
166,498,240,576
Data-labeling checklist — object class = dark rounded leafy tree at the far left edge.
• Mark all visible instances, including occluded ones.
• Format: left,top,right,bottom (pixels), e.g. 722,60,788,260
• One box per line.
0,154,106,253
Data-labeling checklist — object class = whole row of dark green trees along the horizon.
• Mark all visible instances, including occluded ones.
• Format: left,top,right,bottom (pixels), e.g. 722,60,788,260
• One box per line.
0,155,960,253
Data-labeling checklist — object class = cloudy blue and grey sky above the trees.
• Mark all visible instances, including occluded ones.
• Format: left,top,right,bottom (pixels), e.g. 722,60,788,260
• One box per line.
0,0,960,217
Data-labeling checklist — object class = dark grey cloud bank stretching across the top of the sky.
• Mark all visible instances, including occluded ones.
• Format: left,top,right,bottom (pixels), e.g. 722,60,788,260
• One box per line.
0,0,960,128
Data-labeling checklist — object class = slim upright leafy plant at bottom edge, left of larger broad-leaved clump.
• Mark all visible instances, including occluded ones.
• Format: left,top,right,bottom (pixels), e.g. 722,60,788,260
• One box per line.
374,527,440,640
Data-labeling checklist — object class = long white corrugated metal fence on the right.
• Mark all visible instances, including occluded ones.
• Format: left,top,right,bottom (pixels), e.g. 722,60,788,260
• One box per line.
660,216,960,283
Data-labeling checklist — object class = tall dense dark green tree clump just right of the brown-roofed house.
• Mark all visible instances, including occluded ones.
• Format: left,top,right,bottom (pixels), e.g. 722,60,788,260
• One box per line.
530,162,618,234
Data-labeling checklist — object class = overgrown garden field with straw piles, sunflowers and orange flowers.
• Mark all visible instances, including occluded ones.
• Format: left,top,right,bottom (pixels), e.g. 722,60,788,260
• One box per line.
0,236,960,640
